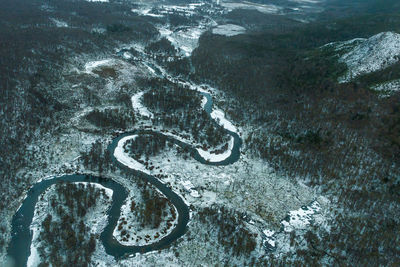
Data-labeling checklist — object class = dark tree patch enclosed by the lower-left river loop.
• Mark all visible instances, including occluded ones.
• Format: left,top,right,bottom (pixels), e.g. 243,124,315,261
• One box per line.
38,184,108,266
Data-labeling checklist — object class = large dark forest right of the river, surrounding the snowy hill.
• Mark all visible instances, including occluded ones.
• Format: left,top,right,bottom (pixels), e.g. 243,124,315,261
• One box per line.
192,6,400,265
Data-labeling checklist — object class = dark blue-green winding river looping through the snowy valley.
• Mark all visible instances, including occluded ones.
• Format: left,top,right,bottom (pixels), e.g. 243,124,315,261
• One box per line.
8,86,241,266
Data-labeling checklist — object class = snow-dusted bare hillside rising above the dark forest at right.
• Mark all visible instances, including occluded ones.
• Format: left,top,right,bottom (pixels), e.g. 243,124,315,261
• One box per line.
335,32,400,82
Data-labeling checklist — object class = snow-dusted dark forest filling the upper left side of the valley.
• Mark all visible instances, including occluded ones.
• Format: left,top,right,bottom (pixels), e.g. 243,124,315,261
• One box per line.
0,0,158,254
